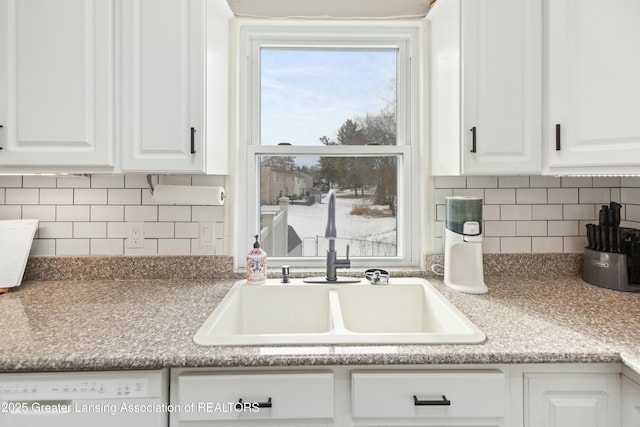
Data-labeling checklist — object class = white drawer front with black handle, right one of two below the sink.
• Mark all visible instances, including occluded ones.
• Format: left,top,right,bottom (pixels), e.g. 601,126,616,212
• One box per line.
351,371,505,418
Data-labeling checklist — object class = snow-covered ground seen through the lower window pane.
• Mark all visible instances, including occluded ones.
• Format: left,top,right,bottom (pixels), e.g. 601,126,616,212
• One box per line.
274,192,397,256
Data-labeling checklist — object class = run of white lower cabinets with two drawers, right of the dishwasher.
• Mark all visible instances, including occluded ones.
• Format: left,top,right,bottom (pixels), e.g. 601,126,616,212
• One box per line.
170,363,640,427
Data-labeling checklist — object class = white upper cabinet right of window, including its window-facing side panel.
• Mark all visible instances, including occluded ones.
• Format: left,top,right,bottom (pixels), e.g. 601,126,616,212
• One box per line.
429,0,542,175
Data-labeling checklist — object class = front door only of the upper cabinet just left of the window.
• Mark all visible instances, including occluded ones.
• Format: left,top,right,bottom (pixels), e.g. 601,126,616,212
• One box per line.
120,0,206,172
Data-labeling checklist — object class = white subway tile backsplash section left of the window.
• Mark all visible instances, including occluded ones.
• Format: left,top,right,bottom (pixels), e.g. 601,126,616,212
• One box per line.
0,175,229,256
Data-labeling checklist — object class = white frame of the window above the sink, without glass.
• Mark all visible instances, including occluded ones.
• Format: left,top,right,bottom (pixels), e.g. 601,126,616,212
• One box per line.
232,20,423,269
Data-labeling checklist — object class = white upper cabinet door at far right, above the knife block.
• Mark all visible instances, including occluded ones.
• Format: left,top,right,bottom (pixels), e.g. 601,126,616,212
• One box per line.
543,0,640,174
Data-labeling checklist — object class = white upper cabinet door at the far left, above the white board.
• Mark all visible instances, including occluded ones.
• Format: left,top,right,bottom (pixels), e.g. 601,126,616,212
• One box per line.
0,0,115,170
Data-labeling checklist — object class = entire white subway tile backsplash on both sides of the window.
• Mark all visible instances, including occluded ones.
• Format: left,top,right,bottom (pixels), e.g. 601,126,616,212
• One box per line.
0,175,640,256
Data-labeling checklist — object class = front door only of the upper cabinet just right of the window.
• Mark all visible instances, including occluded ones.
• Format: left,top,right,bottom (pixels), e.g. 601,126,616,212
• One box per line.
461,0,542,174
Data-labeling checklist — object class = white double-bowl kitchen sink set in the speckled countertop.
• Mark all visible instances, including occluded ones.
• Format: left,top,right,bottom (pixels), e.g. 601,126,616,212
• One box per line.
194,278,486,346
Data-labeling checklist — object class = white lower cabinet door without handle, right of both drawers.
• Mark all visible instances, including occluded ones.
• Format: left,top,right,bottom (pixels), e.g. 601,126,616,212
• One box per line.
524,374,620,427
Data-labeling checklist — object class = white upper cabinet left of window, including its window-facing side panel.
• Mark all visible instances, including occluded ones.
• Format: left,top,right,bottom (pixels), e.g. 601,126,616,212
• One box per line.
119,0,232,174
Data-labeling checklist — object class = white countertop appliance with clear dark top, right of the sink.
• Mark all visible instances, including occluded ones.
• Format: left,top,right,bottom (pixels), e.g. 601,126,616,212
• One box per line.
444,196,488,294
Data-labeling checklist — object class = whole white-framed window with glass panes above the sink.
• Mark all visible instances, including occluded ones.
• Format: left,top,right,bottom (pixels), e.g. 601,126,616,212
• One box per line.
238,23,419,266
